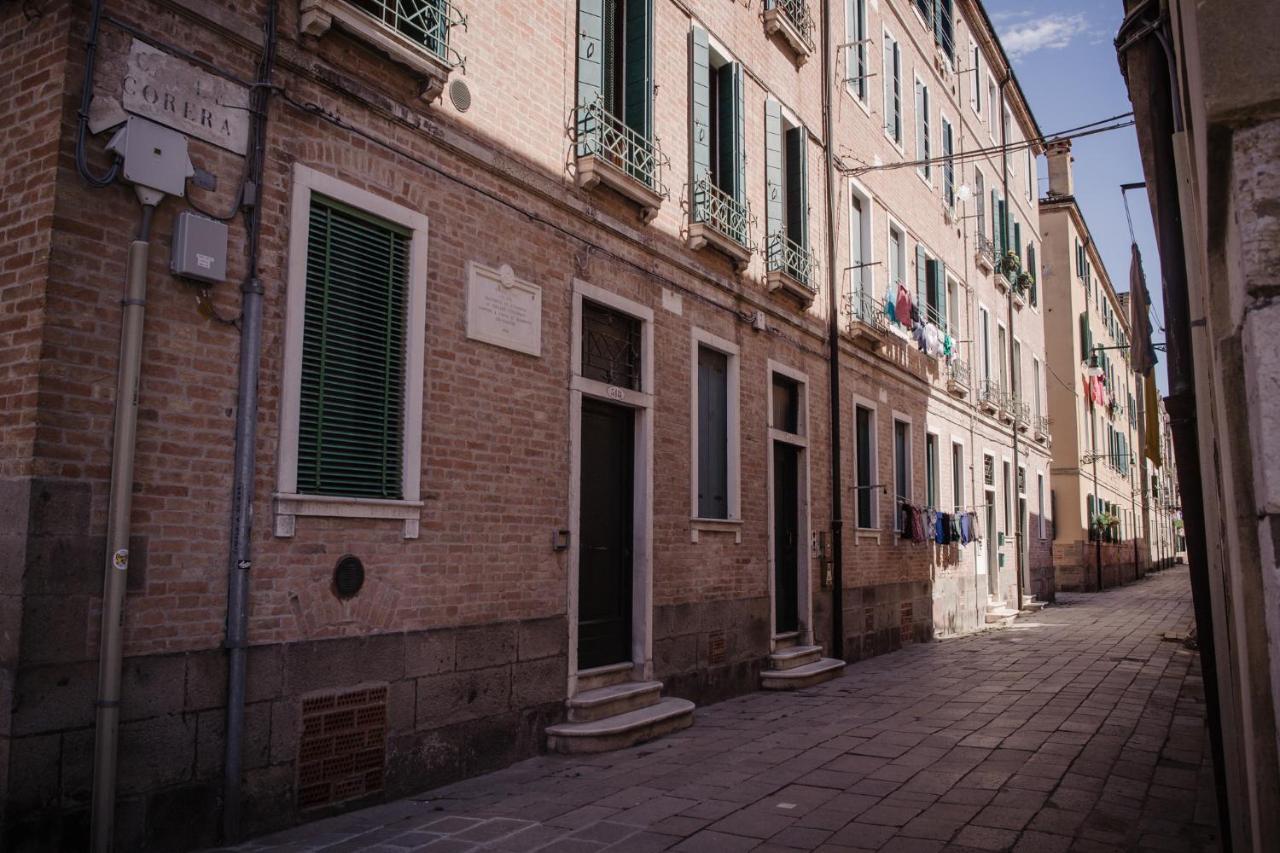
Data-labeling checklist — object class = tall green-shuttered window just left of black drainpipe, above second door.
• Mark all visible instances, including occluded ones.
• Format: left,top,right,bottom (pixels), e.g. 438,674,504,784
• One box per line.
764,97,809,274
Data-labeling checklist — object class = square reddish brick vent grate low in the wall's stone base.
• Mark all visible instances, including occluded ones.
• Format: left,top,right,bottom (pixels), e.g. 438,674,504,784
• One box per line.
298,685,387,809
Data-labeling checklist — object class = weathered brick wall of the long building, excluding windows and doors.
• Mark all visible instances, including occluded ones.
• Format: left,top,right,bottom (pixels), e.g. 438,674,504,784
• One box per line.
0,0,1055,850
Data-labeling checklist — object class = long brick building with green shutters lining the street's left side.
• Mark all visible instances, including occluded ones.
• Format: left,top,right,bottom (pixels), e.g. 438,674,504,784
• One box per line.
0,0,1053,850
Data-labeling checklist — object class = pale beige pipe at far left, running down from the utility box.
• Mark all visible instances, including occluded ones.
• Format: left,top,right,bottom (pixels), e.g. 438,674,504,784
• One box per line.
91,195,163,853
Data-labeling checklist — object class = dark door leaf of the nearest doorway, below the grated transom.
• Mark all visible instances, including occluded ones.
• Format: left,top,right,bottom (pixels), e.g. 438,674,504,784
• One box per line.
577,398,635,670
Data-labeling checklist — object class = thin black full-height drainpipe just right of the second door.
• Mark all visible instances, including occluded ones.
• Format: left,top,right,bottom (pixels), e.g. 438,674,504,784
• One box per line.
822,0,845,658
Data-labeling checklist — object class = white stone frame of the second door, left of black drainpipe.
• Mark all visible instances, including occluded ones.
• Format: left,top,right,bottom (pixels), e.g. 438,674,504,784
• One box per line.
764,359,813,652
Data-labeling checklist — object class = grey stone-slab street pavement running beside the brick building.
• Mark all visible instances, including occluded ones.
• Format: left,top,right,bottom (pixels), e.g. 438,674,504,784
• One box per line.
215,569,1219,853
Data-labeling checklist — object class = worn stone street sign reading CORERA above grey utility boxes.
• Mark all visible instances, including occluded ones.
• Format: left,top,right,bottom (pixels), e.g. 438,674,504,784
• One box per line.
122,40,248,154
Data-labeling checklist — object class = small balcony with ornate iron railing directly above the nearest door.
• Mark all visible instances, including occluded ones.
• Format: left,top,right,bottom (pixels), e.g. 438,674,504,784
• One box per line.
573,101,667,222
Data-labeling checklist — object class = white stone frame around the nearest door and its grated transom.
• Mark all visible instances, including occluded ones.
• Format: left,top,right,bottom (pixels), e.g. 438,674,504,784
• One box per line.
566,278,654,697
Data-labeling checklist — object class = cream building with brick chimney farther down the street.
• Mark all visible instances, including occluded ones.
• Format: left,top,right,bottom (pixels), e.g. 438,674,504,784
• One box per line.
1041,142,1148,589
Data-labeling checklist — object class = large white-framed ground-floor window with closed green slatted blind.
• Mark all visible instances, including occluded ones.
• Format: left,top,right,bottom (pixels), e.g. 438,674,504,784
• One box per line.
275,165,428,538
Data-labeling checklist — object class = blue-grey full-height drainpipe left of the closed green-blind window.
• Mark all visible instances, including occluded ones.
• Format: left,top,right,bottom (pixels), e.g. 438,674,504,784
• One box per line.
223,0,275,843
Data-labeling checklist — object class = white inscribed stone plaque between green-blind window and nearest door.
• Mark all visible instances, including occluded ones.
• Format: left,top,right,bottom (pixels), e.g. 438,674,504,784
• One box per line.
467,261,543,356
